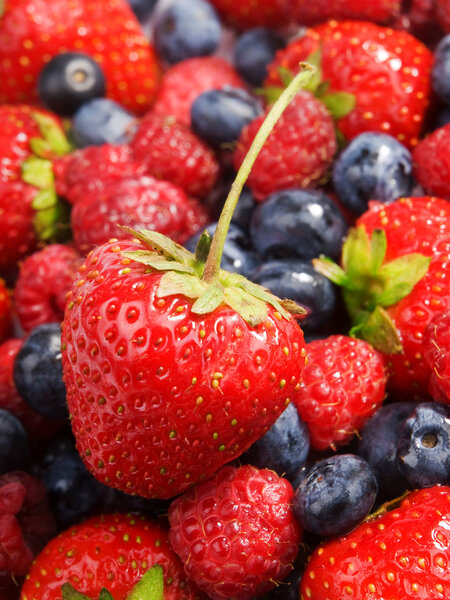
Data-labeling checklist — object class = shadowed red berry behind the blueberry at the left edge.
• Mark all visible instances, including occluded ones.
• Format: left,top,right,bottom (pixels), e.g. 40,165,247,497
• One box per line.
0,338,65,442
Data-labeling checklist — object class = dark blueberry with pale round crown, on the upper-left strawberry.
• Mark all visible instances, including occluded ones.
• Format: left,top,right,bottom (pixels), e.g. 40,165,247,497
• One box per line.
38,52,106,117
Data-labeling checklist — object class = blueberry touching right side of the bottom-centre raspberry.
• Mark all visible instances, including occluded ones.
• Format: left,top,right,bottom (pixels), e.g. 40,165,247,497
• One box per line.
293,454,377,536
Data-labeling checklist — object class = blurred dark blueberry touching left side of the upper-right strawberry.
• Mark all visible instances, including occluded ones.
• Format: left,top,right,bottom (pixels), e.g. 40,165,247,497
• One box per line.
233,27,286,87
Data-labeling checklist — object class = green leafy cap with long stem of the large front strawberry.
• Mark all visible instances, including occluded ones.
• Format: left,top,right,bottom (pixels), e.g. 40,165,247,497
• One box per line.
122,63,315,326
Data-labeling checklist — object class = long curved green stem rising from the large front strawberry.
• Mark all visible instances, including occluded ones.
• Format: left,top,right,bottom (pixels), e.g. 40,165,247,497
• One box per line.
202,63,317,283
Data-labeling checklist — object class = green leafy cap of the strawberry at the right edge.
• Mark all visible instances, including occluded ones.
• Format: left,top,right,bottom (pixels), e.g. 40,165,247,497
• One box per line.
313,226,431,354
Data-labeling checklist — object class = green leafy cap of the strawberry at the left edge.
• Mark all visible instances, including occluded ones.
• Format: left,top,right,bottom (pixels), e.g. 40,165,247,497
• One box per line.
22,110,72,242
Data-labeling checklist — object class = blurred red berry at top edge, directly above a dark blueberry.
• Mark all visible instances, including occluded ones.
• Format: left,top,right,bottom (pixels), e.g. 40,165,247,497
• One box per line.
206,0,291,29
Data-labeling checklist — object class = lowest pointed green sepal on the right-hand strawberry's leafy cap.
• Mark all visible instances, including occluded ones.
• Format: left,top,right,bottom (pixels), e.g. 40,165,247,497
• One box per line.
350,306,403,354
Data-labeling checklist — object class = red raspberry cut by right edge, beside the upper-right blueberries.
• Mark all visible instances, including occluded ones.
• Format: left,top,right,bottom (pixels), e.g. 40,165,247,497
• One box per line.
413,124,450,200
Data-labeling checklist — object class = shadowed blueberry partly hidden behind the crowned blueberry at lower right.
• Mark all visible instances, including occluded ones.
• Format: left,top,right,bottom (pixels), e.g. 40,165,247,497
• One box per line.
357,401,416,500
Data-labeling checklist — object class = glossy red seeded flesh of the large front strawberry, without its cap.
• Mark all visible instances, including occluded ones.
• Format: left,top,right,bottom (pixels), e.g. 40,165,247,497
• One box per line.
62,241,305,498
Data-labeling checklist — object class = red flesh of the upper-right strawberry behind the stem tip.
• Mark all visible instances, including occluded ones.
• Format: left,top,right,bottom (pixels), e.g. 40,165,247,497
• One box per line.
266,21,433,147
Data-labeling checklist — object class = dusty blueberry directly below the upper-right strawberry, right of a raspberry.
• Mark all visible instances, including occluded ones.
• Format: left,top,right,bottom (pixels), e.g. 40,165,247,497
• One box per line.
333,132,413,215
